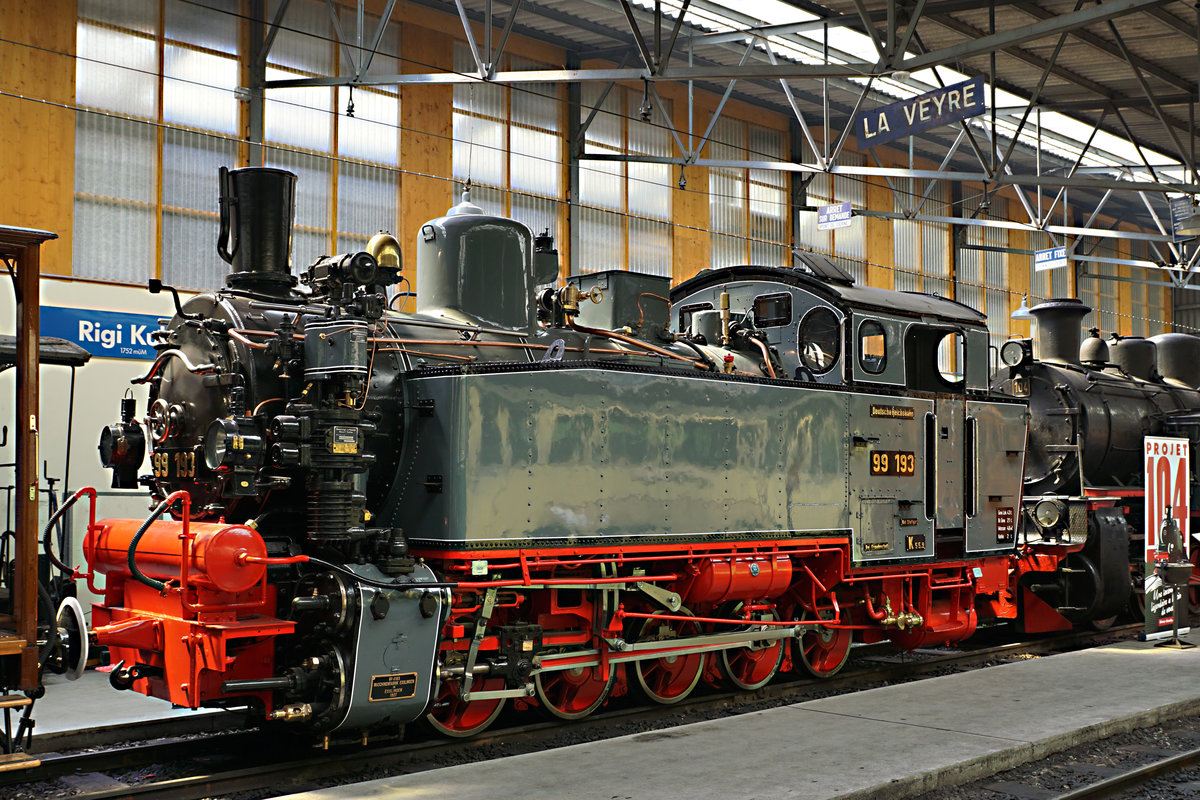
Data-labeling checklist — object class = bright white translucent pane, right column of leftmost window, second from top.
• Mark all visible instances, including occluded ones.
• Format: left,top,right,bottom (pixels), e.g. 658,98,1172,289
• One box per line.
162,44,238,134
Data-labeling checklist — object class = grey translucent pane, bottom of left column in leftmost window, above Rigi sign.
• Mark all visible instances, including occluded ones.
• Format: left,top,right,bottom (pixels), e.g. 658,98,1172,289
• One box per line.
72,197,156,284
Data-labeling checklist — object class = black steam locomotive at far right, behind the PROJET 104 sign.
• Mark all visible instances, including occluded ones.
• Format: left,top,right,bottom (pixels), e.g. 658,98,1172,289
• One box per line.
992,299,1200,631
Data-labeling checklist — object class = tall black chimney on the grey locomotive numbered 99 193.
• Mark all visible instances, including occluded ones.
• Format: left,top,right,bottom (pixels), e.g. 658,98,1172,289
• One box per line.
217,167,296,290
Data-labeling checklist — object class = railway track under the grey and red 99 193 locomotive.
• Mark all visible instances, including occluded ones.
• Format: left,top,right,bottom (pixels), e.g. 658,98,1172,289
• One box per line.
0,625,1140,800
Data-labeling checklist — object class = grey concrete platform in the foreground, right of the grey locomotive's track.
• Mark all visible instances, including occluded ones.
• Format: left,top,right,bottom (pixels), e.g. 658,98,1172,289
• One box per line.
272,642,1200,800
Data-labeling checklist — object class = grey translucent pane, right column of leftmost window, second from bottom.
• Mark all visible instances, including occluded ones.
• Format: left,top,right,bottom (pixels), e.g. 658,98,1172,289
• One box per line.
162,128,238,211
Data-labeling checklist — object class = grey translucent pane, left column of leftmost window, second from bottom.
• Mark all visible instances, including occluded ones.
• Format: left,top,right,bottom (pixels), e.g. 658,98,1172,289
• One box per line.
76,112,157,204
